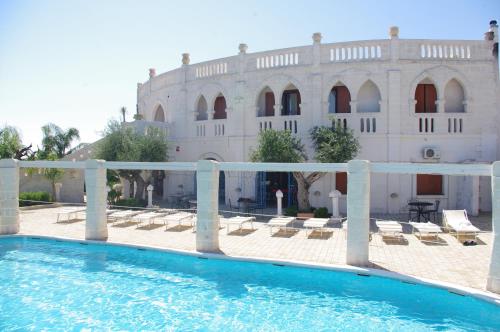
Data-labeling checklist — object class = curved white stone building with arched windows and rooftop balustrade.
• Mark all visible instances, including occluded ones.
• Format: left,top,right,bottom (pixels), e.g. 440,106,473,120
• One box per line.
136,21,500,214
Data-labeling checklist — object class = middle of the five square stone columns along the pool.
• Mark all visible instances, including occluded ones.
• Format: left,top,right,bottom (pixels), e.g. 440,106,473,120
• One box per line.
196,160,219,252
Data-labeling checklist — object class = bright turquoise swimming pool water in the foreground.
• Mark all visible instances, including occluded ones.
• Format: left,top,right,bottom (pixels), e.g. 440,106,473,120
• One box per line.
0,238,500,331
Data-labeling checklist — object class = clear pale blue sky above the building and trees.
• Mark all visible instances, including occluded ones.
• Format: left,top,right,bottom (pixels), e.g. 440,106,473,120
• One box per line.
0,0,500,145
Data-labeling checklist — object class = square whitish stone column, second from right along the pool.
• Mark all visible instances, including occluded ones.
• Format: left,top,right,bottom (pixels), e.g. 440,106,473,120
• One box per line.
346,160,370,266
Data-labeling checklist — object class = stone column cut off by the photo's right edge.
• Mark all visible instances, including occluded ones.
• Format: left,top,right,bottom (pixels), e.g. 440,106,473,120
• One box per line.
486,161,500,293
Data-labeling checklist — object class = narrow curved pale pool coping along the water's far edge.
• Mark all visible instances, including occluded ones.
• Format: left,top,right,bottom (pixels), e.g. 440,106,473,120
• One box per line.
0,234,500,307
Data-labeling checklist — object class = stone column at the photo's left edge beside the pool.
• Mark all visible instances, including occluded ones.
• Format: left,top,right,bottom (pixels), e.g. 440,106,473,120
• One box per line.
0,159,19,235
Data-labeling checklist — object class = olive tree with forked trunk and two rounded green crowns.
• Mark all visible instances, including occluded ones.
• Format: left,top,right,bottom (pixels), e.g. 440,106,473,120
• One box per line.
250,126,360,211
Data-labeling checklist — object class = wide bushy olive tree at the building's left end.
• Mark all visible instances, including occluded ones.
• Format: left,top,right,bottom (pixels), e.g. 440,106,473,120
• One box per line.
96,120,168,200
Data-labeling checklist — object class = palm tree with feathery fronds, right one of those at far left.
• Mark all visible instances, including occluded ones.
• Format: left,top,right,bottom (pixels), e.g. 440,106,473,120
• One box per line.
39,123,80,159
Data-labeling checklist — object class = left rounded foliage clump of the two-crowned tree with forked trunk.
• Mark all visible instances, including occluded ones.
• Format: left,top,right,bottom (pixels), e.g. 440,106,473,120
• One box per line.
250,129,307,163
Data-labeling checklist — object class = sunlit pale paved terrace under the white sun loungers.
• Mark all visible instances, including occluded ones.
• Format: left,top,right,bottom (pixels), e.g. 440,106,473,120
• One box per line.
20,208,492,290
